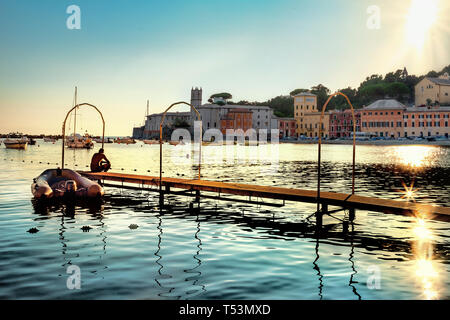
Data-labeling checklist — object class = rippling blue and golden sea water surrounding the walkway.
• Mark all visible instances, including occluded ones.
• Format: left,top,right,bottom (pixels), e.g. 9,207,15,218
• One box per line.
0,140,450,299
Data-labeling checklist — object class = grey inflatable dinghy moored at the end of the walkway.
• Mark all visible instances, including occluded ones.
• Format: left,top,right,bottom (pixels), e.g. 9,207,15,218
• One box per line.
31,169,105,199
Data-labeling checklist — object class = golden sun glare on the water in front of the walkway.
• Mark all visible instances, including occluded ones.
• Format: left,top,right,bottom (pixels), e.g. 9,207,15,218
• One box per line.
412,218,439,300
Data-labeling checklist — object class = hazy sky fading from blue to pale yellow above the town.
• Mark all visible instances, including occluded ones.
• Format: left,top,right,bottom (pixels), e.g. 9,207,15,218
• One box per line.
0,0,450,135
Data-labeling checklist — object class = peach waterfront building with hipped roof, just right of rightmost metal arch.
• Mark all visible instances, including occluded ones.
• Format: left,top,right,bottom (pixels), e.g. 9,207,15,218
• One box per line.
360,99,406,138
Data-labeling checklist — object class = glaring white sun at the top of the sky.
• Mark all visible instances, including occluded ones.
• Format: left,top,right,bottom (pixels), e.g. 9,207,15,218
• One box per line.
405,0,438,49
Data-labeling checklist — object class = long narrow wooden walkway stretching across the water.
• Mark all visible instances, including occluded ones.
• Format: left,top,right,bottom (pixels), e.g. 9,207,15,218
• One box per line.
79,171,450,221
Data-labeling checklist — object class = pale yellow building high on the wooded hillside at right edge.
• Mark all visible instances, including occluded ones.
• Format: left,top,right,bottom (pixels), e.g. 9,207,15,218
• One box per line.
414,72,450,106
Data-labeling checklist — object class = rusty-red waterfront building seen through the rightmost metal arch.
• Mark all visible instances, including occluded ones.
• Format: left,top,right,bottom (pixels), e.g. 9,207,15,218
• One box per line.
329,109,361,138
